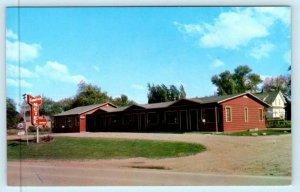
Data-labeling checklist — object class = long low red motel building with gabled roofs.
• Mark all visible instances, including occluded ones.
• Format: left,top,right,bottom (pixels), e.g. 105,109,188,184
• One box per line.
52,93,270,132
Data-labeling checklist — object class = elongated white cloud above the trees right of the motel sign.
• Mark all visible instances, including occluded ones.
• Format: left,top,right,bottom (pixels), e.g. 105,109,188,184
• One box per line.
35,61,87,84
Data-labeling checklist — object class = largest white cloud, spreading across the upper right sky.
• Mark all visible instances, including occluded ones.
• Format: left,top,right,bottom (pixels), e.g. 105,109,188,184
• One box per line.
175,7,290,49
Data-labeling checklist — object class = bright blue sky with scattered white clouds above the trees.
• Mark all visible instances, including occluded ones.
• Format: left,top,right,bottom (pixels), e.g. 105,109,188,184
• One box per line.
6,7,291,106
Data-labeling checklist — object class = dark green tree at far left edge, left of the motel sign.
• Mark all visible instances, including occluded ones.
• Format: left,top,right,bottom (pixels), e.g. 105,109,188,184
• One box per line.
6,97,21,129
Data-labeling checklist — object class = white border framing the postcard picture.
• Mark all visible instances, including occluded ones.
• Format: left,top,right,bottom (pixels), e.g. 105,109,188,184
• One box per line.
0,0,300,192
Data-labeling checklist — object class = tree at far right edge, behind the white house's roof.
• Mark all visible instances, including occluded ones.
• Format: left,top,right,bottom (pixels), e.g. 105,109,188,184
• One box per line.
262,75,291,96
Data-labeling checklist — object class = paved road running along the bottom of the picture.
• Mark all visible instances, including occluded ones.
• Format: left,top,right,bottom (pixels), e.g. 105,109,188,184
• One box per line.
7,162,291,186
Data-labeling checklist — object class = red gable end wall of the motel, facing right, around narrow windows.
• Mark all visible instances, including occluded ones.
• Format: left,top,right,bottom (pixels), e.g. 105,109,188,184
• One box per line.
221,96,266,132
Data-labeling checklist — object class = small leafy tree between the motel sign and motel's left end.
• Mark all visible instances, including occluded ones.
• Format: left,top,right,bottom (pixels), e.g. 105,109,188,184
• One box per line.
40,97,63,115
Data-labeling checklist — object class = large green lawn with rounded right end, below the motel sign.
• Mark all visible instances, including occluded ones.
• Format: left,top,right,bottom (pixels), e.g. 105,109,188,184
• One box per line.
7,137,205,160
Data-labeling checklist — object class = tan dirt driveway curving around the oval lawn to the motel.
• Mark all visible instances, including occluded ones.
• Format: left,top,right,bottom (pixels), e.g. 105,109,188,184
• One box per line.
8,133,291,176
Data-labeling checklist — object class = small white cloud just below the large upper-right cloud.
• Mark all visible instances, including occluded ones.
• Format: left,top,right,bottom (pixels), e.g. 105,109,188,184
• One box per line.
250,42,275,59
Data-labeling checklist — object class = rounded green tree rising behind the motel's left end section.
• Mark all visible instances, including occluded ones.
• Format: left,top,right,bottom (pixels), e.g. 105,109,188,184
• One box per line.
72,81,110,108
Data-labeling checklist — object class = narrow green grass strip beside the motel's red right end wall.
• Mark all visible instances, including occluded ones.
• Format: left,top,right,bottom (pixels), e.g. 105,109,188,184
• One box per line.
225,129,291,136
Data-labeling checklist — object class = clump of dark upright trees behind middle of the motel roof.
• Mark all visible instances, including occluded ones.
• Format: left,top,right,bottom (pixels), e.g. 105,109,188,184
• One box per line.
148,83,186,103
